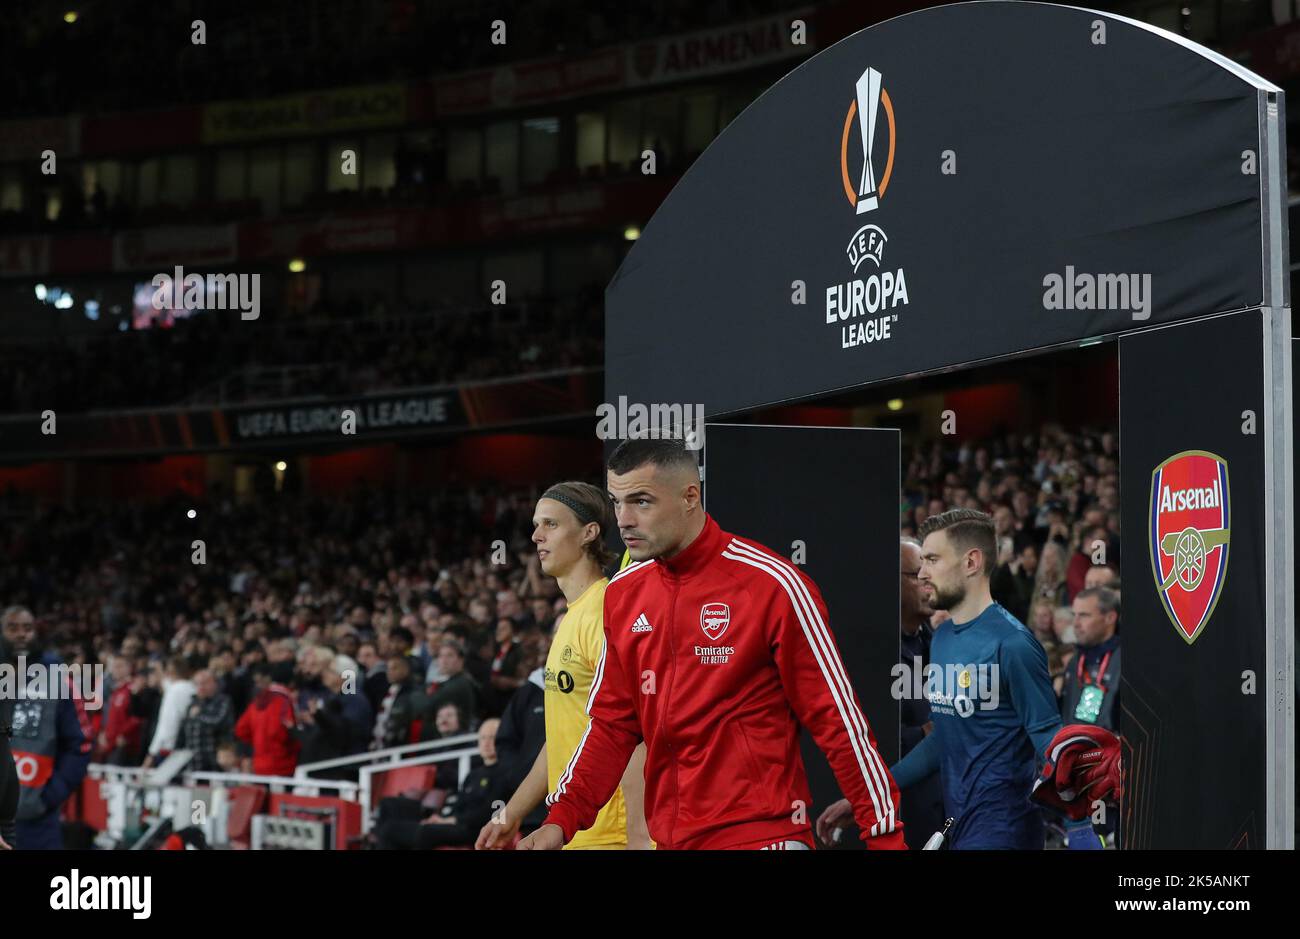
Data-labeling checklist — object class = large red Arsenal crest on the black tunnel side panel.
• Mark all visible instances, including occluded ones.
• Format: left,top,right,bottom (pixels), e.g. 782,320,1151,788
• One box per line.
1148,450,1230,644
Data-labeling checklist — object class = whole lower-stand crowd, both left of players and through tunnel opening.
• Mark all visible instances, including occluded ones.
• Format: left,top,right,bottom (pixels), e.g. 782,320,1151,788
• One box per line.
0,427,1119,844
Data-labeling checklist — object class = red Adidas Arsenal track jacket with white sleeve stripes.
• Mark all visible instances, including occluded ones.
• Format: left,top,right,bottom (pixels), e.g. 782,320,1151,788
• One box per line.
546,515,905,849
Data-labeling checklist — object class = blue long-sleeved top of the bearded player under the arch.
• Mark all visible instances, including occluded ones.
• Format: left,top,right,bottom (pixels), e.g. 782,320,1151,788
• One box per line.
893,603,1061,851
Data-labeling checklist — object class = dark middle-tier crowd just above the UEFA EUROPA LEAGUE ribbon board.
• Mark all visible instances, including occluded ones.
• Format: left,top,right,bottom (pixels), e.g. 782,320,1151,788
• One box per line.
0,295,603,414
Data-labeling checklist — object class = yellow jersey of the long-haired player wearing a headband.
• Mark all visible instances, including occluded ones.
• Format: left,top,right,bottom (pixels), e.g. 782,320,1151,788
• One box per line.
545,577,628,848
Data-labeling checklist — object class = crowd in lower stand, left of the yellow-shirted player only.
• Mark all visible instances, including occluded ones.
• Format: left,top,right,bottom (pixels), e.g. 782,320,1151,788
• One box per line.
3,476,564,832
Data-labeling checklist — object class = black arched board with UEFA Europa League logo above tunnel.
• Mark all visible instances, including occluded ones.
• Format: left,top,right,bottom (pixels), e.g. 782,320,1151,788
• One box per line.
606,0,1286,416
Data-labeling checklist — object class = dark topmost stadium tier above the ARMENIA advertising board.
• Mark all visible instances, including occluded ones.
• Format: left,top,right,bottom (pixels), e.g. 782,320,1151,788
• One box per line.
0,0,803,120
